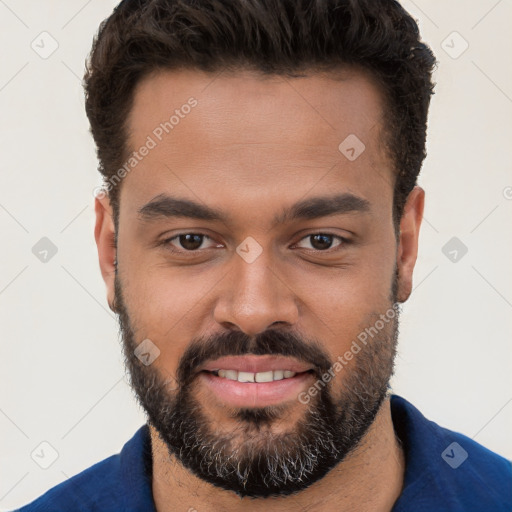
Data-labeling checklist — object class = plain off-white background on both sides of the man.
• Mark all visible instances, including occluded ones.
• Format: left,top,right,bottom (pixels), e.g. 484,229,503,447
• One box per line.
0,0,512,510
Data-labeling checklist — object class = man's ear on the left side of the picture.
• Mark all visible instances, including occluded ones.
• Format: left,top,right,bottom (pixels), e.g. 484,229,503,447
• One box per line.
94,194,117,313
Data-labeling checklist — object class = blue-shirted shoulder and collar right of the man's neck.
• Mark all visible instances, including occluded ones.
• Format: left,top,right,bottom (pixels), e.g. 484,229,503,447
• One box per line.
392,395,512,512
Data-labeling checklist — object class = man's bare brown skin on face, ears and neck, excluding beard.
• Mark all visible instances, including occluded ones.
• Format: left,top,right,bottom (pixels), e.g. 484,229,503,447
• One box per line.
95,69,424,512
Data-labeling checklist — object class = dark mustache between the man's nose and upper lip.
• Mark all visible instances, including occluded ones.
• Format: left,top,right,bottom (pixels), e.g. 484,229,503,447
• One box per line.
176,329,332,384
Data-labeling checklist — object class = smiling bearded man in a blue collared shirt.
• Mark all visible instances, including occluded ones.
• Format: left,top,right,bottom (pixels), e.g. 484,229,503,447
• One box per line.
16,0,512,512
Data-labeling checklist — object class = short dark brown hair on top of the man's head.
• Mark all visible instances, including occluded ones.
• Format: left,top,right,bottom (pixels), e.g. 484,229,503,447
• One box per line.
84,0,436,228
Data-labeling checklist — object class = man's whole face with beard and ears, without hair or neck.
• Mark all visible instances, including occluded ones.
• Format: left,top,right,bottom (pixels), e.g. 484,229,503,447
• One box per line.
96,70,423,497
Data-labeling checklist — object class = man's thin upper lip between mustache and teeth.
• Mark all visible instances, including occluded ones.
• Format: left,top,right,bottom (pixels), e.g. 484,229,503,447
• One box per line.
200,355,314,373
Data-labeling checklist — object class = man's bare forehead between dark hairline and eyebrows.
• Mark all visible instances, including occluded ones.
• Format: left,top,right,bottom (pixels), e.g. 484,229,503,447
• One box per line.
121,69,392,220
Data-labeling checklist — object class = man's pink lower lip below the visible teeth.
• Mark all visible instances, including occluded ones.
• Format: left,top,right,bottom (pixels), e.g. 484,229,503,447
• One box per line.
199,371,314,407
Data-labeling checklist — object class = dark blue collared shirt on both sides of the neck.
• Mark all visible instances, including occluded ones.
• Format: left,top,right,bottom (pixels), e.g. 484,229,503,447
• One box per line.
14,395,512,512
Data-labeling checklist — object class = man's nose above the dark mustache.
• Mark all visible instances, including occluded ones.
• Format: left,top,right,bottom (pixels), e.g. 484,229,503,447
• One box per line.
214,250,299,336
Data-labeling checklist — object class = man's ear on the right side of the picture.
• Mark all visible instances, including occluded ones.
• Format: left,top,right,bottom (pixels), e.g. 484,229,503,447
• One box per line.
396,187,425,302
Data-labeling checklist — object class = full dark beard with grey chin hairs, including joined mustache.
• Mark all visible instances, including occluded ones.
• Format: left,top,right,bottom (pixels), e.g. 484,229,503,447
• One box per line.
114,269,399,498
